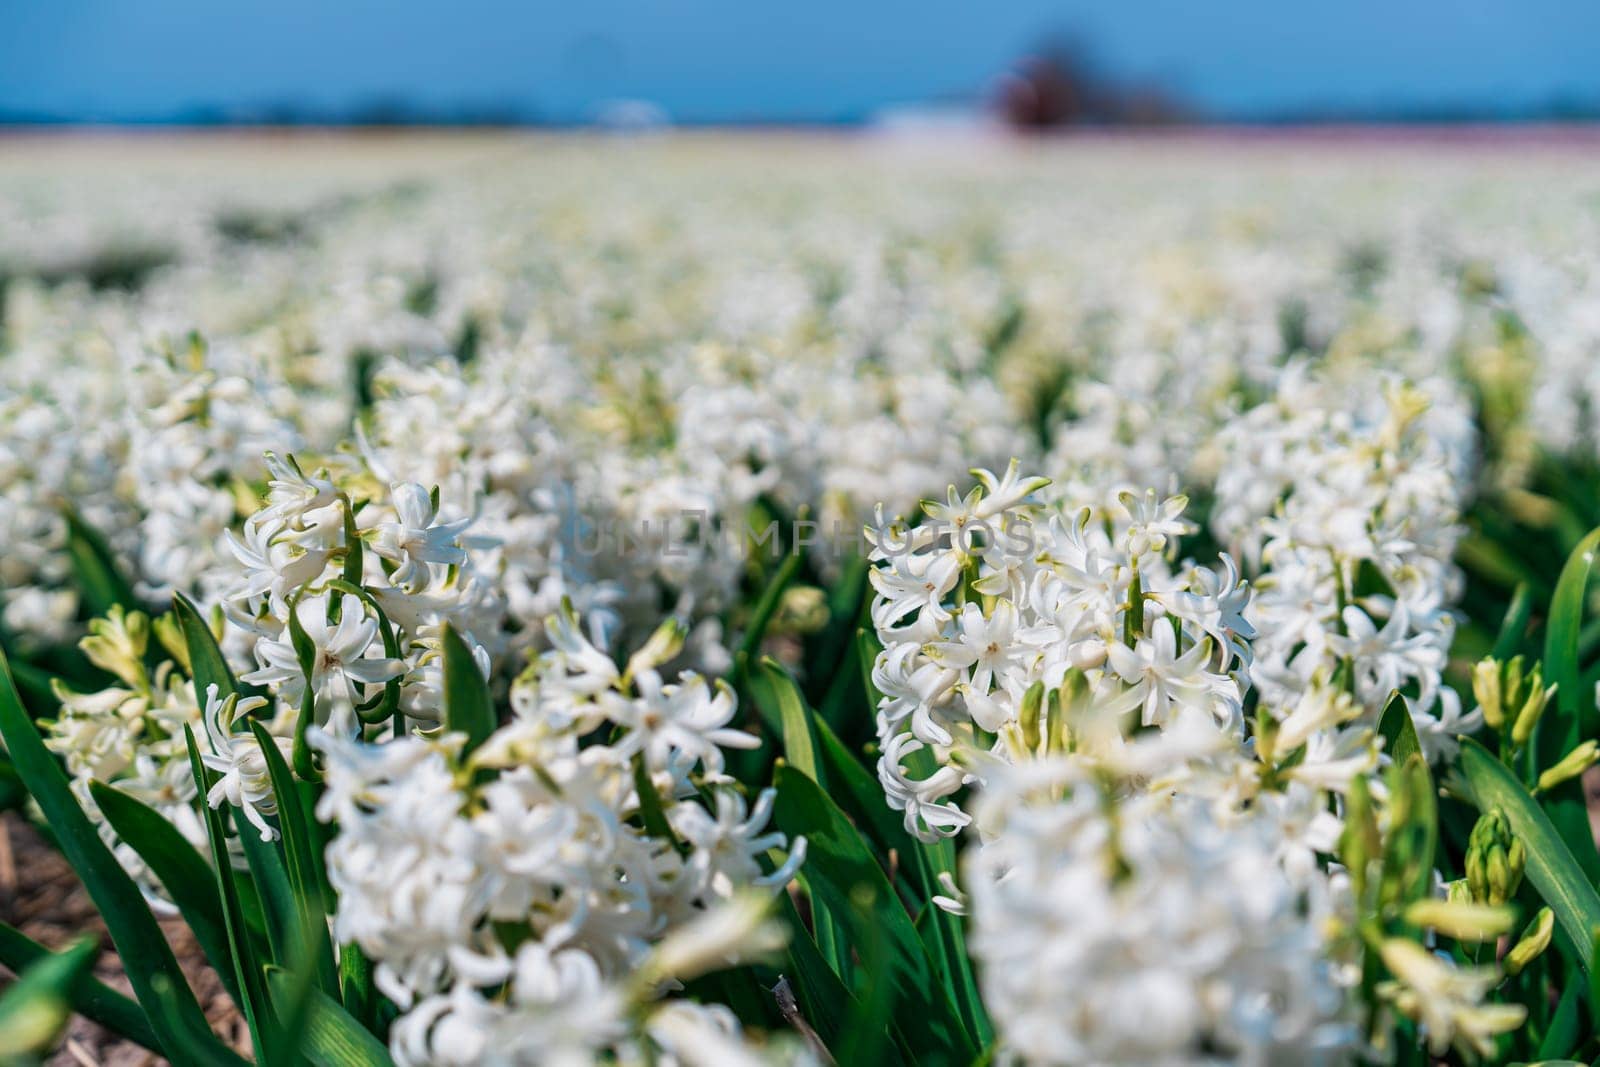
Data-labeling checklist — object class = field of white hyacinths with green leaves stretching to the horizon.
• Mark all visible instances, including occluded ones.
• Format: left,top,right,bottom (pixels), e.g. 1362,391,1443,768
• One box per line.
0,134,1600,1067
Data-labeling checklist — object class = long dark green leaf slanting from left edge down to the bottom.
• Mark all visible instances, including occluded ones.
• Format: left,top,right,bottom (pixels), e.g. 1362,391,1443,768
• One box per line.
0,654,243,1064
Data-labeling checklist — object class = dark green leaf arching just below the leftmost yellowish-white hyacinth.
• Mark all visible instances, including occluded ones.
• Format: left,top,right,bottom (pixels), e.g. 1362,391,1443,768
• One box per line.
90,782,238,1001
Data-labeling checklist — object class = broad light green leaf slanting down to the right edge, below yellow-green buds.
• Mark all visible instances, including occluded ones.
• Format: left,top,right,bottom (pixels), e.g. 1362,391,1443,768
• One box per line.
1461,737,1600,974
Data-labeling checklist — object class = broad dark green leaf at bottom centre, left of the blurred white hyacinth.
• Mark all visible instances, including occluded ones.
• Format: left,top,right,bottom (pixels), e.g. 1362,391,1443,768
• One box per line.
774,766,978,1062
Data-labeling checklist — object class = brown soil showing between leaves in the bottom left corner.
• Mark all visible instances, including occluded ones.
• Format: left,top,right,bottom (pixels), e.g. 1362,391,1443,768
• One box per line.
0,811,250,1067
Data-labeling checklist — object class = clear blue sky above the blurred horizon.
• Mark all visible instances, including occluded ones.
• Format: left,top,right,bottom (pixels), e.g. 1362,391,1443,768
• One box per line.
9,0,1600,122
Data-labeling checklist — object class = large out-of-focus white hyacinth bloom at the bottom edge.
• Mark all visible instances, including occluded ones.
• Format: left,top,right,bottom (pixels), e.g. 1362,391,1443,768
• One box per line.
963,763,1354,1064
